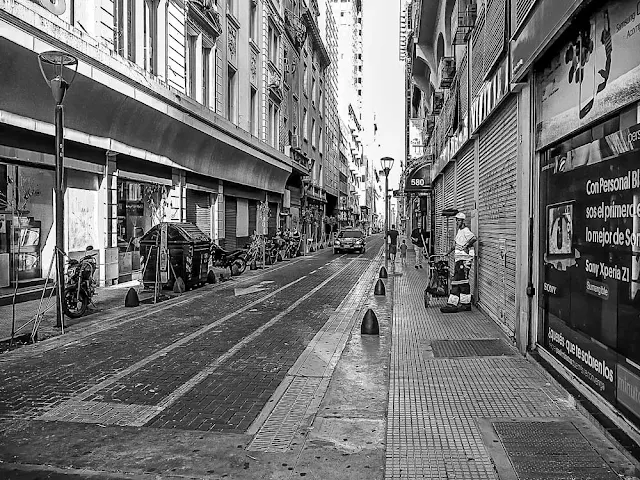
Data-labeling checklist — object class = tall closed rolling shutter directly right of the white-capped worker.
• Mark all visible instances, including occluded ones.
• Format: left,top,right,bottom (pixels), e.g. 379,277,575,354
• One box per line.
478,98,518,332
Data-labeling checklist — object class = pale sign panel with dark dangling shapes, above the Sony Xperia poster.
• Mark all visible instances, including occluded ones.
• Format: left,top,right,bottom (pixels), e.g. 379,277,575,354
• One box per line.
536,0,640,148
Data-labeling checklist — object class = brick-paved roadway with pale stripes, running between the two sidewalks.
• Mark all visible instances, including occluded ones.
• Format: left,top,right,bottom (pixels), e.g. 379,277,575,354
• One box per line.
0,235,391,478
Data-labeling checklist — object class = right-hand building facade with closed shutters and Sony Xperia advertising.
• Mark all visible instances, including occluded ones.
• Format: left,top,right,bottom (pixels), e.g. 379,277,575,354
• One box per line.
407,0,640,452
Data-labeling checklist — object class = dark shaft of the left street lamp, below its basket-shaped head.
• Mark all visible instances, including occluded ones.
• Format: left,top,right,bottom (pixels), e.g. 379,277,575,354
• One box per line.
55,105,64,328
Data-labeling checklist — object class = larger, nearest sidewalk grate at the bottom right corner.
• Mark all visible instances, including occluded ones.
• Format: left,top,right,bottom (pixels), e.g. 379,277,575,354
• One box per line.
493,421,618,480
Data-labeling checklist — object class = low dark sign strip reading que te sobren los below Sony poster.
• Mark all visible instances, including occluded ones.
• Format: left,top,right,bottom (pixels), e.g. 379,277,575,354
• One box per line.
546,317,616,402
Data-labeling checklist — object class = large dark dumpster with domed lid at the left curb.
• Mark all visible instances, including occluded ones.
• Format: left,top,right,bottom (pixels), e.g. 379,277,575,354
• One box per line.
140,222,211,288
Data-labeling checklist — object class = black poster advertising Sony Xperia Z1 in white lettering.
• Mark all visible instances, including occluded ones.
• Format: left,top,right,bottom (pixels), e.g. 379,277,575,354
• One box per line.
541,124,640,391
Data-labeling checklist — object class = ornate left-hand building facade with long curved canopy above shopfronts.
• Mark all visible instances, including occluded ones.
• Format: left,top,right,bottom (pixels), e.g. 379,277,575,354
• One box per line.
0,0,329,285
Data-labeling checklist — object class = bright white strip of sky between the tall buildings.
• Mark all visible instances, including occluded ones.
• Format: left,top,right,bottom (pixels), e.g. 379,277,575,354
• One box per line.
362,0,405,190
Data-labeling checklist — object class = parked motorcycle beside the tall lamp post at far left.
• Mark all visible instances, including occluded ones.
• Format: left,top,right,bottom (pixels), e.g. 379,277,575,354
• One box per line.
63,245,98,318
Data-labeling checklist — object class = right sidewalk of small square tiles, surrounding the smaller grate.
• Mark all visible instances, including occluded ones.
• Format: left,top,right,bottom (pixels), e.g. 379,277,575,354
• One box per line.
385,262,576,480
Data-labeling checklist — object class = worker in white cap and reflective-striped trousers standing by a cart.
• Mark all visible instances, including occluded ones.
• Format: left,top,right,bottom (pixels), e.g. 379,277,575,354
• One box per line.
440,212,476,313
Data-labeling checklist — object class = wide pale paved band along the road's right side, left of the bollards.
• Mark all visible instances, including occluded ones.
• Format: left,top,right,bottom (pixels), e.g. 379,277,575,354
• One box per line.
247,249,382,452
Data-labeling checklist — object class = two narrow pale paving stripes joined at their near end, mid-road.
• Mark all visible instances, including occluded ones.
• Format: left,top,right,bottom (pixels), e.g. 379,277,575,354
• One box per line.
39,264,356,426
